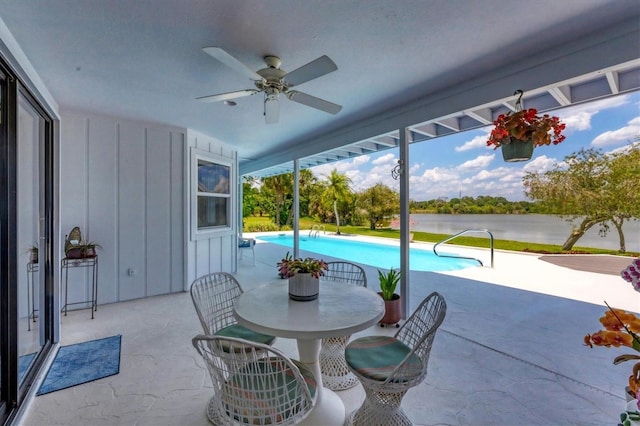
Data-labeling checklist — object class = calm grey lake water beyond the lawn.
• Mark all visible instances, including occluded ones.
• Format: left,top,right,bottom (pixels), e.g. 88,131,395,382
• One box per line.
411,214,640,252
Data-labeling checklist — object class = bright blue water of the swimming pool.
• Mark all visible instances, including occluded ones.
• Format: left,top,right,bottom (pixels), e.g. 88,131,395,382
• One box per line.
257,235,478,272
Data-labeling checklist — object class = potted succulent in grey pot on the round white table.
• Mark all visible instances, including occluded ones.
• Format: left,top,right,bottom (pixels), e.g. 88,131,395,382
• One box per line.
277,253,328,302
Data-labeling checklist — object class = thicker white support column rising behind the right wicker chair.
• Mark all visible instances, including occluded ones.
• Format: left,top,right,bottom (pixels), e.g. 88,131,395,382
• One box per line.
399,127,410,319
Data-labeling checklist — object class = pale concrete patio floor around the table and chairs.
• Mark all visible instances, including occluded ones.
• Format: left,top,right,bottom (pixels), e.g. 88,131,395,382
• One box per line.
19,236,640,426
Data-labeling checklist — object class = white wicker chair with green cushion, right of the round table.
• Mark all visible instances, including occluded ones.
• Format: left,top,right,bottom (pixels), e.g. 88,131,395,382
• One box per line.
345,292,447,426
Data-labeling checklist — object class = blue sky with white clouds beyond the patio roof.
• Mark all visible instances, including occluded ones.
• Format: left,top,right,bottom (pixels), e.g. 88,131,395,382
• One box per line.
310,92,640,201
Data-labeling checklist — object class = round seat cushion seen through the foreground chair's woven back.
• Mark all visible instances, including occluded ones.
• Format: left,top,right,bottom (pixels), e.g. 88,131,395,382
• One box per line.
221,358,318,425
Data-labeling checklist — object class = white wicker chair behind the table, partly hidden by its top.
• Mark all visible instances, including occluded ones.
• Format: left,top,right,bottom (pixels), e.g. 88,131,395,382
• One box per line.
320,262,367,390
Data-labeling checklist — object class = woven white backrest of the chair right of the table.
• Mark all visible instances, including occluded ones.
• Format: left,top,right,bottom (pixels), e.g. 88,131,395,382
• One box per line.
387,292,447,383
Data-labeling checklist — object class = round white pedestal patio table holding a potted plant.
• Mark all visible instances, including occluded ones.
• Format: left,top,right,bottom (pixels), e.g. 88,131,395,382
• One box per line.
234,280,384,426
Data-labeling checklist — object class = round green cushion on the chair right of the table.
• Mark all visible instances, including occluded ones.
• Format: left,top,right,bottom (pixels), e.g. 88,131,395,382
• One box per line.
344,336,422,382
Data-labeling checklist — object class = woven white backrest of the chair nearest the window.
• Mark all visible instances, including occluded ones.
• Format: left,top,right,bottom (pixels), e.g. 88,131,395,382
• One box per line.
191,272,242,334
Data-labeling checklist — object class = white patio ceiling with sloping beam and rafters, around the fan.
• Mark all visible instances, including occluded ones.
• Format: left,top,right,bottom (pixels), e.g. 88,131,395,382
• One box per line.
0,0,640,174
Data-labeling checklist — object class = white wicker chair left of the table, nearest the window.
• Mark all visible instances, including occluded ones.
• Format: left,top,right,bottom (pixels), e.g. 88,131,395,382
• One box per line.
191,272,276,345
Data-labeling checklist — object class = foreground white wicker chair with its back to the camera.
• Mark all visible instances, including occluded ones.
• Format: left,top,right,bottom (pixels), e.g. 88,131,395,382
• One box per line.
192,335,317,425
